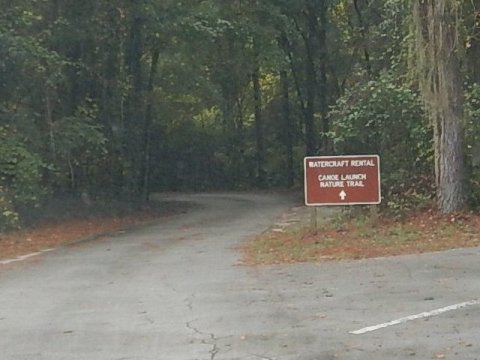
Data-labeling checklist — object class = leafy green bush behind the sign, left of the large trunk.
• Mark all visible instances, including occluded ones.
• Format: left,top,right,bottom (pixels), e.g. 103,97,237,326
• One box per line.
330,74,433,214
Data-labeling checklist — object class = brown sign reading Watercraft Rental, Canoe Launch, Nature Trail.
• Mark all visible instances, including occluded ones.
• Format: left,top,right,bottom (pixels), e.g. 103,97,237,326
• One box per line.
304,155,381,206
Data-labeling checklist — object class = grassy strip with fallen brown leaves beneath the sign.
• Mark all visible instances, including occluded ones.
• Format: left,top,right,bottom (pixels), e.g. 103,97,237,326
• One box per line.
243,210,480,265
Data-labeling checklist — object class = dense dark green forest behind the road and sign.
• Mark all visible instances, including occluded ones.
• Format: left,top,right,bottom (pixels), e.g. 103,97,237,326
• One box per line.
0,0,480,228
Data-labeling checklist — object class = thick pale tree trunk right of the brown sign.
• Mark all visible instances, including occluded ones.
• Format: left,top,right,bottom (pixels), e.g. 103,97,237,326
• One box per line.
414,0,466,213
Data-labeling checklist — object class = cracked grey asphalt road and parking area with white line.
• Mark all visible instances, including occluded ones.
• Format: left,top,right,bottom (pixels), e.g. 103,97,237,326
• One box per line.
0,194,480,360
